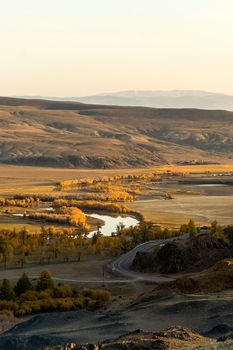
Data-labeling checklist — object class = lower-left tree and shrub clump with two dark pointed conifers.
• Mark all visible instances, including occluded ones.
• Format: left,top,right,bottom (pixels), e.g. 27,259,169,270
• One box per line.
0,270,111,317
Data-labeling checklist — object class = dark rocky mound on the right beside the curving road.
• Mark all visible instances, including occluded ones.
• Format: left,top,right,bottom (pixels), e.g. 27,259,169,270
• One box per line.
133,234,232,274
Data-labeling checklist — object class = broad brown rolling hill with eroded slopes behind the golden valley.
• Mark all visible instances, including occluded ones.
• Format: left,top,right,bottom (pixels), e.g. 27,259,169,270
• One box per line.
0,97,233,168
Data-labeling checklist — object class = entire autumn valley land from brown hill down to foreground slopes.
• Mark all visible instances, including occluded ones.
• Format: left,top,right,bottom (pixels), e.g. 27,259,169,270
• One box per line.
0,98,233,350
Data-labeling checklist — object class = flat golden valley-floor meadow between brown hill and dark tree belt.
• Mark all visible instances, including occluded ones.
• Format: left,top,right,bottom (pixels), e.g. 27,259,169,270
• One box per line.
0,164,233,231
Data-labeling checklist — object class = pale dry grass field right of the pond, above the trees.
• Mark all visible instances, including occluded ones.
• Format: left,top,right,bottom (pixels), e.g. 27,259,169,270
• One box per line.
129,196,233,228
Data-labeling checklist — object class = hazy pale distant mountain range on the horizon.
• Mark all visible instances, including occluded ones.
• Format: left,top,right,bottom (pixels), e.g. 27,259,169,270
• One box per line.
19,90,233,111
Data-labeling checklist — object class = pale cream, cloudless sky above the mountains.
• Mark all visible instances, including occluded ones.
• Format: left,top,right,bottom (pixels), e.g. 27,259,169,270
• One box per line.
0,0,233,97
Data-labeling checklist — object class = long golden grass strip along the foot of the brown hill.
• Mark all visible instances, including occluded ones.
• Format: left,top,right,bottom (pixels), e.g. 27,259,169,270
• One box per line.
0,164,233,195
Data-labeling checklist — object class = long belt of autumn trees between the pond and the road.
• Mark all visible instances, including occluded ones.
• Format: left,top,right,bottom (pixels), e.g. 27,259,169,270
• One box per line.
0,220,226,269
